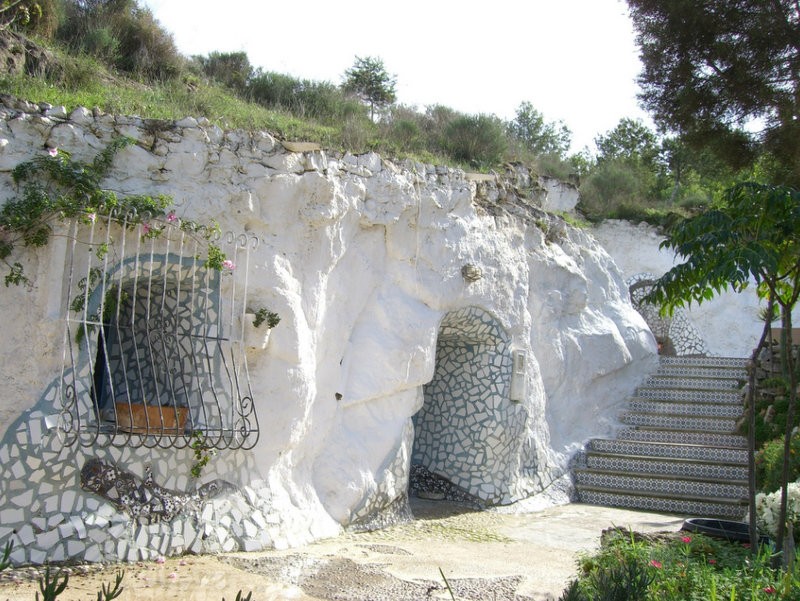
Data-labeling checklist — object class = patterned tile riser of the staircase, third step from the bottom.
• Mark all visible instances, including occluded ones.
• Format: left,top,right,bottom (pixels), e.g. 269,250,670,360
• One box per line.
586,454,747,481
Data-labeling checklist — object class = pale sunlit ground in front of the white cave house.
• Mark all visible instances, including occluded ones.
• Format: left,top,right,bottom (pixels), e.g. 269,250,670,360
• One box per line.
0,499,683,601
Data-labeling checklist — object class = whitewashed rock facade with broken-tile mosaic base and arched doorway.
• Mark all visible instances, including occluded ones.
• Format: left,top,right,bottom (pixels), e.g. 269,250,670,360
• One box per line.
0,98,656,563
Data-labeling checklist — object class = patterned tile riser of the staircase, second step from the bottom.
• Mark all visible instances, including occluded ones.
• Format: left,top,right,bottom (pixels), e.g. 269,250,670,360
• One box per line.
575,471,747,500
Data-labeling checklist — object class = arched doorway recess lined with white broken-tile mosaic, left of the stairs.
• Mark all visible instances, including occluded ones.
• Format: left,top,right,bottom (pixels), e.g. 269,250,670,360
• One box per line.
411,307,527,505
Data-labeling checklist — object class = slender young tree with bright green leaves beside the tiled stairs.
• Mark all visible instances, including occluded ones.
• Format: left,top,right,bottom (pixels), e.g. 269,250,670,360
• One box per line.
648,182,800,564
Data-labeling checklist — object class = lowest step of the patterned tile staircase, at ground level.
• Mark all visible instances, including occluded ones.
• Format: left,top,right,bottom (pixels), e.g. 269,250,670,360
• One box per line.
578,489,747,520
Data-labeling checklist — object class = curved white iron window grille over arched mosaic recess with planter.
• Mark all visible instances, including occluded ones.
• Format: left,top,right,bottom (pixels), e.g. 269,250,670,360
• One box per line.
58,212,259,449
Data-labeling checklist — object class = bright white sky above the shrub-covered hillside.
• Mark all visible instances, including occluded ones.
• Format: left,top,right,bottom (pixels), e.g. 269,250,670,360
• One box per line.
141,0,651,151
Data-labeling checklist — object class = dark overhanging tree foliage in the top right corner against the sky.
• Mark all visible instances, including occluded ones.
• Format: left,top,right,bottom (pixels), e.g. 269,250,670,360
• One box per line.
628,0,800,186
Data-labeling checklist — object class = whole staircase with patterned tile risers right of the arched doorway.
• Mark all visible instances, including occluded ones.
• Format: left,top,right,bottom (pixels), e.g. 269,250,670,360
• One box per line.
573,357,747,519
